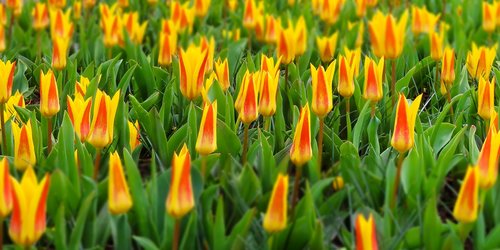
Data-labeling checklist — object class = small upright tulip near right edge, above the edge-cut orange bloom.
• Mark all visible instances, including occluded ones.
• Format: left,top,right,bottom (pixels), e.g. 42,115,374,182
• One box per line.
477,77,495,120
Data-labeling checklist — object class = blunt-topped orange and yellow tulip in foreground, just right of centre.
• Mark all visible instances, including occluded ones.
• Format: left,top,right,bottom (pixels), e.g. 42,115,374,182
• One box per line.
263,174,288,233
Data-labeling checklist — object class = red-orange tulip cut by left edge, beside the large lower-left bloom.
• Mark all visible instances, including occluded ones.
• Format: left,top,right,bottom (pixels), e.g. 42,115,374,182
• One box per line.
0,157,13,219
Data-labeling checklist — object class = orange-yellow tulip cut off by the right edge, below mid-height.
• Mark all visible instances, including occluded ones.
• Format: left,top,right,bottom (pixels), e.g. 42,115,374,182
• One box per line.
477,124,500,190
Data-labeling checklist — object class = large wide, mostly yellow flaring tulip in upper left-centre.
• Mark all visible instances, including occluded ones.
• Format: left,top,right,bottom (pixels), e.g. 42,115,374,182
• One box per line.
179,45,208,100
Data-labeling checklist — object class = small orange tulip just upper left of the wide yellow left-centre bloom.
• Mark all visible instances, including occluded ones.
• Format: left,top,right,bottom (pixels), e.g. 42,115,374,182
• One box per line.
158,20,177,67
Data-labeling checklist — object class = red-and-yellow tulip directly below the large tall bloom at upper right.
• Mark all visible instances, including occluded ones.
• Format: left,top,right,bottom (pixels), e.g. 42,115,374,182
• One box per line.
363,56,384,102
